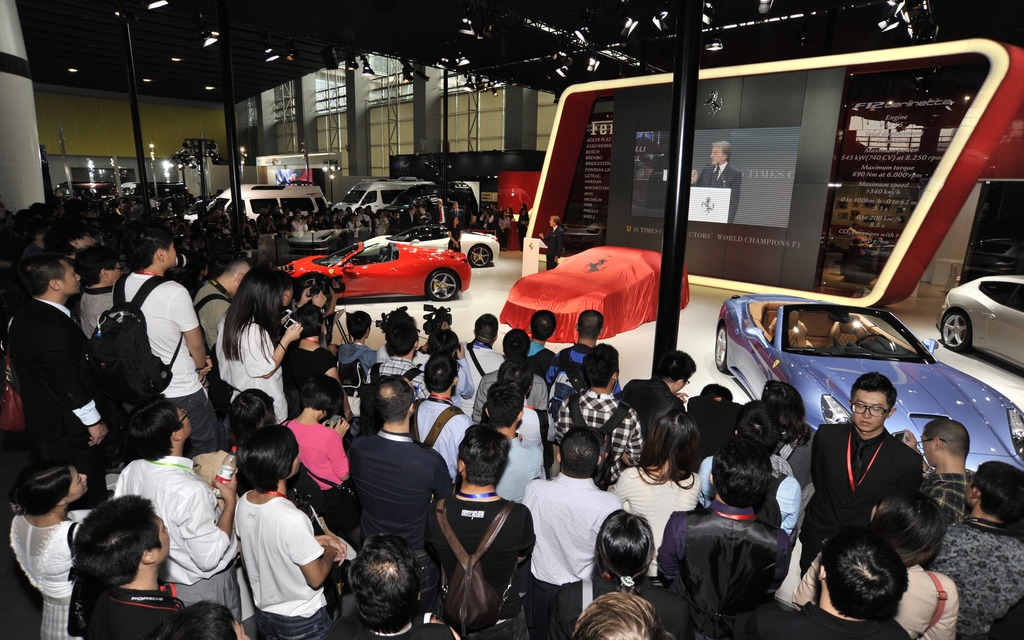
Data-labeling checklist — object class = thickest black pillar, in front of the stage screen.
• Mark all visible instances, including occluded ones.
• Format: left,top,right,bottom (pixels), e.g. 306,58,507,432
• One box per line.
652,0,703,369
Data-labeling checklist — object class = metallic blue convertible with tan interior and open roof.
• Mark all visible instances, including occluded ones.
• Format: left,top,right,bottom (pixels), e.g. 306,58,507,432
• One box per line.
715,294,1024,468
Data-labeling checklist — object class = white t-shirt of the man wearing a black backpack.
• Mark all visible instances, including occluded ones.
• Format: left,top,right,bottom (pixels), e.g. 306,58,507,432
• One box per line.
125,273,203,398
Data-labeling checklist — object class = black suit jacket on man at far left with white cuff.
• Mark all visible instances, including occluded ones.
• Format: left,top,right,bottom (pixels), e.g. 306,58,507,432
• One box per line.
9,300,95,446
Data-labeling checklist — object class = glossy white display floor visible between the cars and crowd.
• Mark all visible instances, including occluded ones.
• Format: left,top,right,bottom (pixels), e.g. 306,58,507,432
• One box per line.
349,252,1024,407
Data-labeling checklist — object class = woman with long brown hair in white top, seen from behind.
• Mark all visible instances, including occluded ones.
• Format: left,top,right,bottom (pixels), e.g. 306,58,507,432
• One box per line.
608,409,700,575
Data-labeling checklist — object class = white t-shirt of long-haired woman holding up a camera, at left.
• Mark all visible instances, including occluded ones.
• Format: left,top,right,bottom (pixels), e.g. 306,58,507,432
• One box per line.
210,318,288,423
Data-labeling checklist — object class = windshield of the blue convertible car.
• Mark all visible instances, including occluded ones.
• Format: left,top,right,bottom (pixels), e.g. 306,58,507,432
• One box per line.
781,304,931,362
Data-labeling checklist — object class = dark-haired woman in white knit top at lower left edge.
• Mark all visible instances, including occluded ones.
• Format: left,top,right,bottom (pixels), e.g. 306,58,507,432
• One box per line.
10,460,88,640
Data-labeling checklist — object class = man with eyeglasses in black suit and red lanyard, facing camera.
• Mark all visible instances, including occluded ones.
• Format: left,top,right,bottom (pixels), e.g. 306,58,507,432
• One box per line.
800,372,923,572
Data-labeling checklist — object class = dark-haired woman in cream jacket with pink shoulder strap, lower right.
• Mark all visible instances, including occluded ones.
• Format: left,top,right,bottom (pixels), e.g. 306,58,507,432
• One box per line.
793,488,959,640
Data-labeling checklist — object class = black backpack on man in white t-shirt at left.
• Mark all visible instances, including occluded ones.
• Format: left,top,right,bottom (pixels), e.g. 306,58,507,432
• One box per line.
85,275,182,403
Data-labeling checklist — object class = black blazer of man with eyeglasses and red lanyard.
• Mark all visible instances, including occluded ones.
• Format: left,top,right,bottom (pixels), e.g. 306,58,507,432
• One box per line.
800,424,923,558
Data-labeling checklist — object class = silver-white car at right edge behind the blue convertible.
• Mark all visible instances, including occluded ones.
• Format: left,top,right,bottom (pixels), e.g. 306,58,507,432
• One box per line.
936,275,1024,367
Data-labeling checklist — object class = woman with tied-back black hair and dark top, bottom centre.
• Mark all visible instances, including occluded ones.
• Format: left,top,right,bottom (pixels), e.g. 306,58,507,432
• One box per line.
548,510,691,640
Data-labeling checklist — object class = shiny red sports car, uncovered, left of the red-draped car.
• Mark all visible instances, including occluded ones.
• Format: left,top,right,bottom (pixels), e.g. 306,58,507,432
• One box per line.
282,243,471,301
